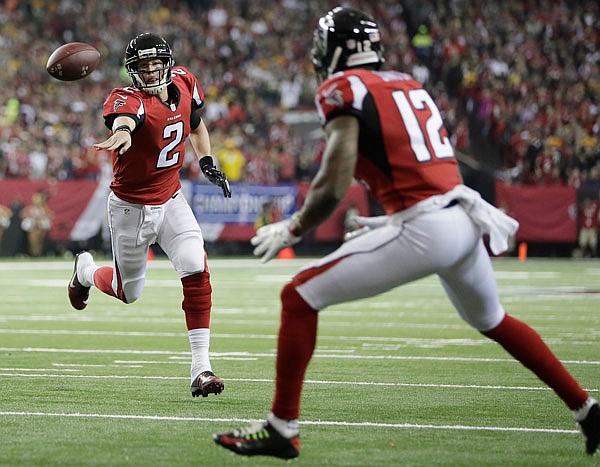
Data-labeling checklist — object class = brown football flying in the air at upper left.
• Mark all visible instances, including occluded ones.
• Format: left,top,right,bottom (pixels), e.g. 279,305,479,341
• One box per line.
46,42,100,81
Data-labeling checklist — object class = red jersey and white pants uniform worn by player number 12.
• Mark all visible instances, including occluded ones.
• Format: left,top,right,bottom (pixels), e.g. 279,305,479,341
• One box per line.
292,69,516,330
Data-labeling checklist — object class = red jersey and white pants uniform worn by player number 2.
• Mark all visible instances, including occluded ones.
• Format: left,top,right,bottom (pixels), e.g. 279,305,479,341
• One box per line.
104,67,206,303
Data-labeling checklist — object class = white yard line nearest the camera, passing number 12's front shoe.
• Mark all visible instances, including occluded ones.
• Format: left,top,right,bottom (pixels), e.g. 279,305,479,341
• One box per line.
0,412,580,434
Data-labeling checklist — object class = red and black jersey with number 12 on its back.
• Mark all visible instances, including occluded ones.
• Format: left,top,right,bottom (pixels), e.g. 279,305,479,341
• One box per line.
315,69,462,214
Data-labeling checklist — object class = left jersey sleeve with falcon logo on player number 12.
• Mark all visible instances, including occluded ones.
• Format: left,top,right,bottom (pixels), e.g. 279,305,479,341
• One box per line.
315,75,364,125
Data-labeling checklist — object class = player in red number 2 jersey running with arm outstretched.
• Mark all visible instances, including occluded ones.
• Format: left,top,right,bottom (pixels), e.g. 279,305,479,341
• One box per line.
68,33,231,397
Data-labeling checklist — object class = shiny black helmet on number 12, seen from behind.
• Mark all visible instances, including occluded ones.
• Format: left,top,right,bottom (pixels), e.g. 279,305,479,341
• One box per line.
310,7,385,80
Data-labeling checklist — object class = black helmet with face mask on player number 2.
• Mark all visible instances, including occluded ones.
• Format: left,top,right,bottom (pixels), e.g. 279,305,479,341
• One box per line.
125,32,175,94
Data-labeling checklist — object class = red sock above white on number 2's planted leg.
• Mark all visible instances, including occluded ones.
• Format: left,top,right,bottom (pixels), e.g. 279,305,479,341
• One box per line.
181,270,212,330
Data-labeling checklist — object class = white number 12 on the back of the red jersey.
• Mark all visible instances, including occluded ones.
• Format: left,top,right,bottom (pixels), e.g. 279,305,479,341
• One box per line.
392,89,454,162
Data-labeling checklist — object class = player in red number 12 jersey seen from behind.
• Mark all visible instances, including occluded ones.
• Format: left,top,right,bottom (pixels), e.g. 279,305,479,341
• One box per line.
214,7,600,458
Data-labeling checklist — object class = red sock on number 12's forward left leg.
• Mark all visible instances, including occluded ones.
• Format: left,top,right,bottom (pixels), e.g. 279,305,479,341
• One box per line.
271,283,318,420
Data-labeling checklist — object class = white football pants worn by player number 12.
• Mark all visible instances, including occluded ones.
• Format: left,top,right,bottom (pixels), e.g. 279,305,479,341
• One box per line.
297,204,504,331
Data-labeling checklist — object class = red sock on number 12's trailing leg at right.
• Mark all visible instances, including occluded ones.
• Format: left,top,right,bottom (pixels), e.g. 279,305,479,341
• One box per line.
482,315,588,410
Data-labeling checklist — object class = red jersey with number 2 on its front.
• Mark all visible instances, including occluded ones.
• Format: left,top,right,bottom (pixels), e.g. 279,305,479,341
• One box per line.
104,67,204,205
